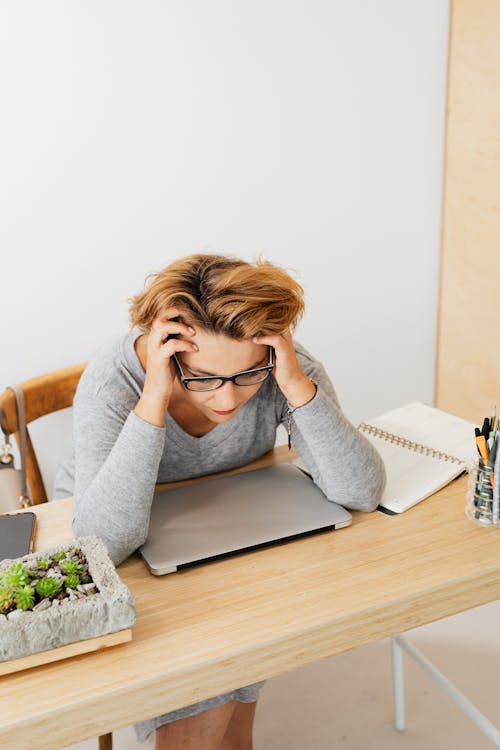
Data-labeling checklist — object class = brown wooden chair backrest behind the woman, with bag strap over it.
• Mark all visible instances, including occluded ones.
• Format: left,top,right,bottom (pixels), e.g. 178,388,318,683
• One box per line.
0,363,87,504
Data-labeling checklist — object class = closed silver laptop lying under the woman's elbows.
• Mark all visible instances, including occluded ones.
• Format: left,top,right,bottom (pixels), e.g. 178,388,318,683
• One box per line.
139,464,352,575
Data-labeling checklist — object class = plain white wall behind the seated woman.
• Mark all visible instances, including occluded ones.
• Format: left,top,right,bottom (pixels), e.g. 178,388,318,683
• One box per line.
0,0,448,496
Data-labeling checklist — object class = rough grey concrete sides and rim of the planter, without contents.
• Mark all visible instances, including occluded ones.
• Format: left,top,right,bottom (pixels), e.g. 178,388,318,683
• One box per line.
0,536,136,662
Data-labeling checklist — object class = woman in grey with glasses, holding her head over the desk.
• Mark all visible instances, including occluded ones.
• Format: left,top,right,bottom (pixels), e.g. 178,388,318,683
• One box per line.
55,255,385,750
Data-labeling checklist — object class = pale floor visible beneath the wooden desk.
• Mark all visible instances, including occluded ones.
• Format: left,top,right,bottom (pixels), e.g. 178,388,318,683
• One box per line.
63,602,500,750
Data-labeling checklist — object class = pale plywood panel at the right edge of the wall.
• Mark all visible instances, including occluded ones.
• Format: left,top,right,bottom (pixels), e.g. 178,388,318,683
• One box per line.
435,0,500,421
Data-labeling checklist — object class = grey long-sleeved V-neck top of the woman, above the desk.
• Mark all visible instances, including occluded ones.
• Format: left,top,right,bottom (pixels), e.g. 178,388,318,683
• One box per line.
54,332,385,565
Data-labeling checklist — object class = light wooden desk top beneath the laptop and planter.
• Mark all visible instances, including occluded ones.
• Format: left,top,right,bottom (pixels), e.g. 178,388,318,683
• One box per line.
0,447,500,750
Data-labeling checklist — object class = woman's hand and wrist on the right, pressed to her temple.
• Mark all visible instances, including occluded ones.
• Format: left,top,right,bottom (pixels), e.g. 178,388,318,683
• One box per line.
253,330,316,408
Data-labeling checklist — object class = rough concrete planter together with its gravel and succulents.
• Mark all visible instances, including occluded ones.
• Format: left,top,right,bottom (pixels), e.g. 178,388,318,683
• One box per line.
0,536,136,661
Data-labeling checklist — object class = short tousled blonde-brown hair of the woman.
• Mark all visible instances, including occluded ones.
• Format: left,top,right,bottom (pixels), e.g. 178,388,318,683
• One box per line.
130,254,304,339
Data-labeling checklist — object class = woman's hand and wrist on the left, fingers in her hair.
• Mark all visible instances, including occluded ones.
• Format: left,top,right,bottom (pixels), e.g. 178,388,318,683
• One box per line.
134,307,198,427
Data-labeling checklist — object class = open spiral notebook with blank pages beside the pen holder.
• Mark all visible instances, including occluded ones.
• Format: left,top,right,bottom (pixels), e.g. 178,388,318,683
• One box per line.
359,401,477,513
